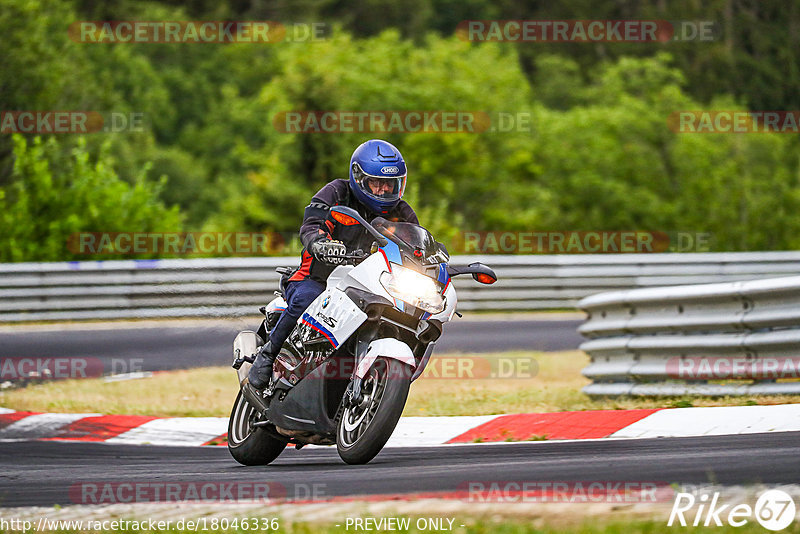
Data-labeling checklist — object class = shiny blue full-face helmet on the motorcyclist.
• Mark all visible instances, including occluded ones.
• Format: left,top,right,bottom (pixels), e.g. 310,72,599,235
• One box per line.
350,139,406,213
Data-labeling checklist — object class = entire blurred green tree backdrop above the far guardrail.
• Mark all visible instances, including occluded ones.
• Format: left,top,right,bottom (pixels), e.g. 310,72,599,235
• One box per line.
0,0,800,261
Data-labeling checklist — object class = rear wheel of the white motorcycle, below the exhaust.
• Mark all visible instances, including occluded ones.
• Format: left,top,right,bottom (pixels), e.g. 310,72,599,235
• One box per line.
228,390,287,465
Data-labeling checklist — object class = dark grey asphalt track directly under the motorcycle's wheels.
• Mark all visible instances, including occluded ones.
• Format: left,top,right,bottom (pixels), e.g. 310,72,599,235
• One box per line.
0,432,800,507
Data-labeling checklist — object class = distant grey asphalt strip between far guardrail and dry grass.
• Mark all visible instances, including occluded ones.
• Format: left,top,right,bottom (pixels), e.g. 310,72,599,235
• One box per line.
0,318,583,373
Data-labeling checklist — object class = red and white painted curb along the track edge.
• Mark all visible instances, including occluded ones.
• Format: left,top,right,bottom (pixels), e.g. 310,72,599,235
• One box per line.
0,404,800,447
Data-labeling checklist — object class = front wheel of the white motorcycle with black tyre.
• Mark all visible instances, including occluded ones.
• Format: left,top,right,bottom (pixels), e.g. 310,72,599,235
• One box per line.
336,357,411,464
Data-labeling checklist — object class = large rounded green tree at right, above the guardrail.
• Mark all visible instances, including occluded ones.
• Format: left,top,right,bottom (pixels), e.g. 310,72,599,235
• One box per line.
510,55,800,250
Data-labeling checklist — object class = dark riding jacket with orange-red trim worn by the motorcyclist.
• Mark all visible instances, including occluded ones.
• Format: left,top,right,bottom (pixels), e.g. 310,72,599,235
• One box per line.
289,180,419,283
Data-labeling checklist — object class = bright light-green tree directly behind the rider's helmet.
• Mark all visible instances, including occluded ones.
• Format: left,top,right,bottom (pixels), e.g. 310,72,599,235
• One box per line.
214,31,530,244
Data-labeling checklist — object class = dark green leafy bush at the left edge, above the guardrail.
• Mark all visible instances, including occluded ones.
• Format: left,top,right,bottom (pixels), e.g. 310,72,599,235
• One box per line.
0,135,181,262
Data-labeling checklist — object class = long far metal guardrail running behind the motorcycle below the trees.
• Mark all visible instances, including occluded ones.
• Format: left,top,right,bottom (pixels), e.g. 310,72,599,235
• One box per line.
0,252,800,322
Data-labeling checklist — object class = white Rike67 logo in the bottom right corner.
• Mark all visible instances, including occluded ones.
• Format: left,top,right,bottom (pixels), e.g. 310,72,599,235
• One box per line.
667,489,795,530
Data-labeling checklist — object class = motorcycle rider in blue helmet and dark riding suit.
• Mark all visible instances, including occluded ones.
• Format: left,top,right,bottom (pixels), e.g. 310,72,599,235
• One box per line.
248,139,419,389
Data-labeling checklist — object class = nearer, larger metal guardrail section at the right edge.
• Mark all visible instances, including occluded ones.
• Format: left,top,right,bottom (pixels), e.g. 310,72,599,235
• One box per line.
578,276,800,396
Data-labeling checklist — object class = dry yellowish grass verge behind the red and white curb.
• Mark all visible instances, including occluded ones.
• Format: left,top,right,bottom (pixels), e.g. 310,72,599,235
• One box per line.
0,351,800,417
